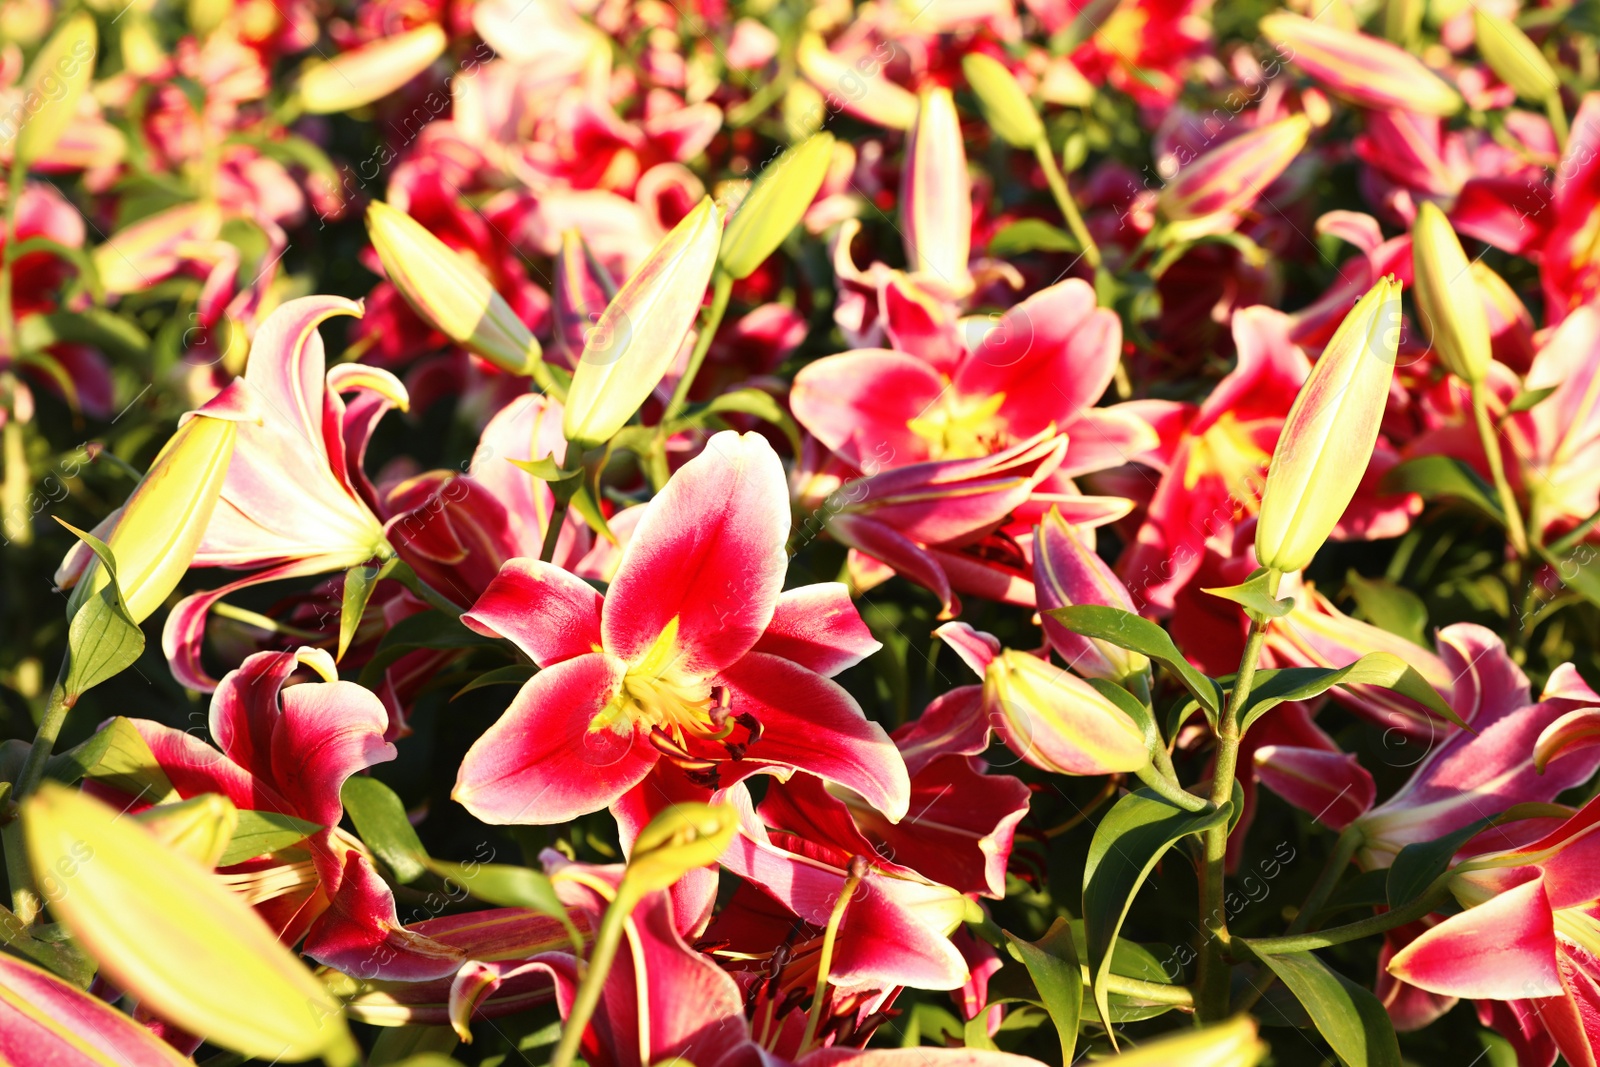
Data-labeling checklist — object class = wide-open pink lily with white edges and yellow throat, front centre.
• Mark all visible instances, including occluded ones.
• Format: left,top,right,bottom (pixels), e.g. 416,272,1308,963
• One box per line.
454,430,909,824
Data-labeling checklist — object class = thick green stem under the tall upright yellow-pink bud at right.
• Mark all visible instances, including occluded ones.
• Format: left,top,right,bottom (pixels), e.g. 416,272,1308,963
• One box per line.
1195,617,1277,1022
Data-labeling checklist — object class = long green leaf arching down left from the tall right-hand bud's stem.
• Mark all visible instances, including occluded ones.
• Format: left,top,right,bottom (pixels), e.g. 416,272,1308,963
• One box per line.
1083,790,1232,1036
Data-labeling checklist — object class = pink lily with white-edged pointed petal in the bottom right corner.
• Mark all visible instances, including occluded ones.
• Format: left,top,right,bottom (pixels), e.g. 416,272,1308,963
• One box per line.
1387,800,1600,1067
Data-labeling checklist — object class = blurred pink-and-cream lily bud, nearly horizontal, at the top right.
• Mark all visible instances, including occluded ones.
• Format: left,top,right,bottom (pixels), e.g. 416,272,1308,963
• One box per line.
1261,11,1461,115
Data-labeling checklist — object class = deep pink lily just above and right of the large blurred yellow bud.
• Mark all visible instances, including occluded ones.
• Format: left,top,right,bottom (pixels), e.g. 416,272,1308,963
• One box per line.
91,648,462,979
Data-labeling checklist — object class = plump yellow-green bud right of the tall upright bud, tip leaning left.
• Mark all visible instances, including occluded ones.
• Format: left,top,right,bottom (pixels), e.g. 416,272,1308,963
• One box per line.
1411,200,1493,386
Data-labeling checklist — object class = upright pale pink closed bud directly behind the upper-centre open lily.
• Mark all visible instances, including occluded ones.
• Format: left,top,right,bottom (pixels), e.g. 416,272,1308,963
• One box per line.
901,90,973,290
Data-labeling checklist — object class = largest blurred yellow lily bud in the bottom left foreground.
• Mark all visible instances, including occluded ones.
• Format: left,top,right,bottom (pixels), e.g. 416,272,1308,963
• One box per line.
21,782,358,1064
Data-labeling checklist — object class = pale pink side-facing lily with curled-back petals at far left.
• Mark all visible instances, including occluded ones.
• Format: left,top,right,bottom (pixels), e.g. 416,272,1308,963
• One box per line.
162,296,406,691
